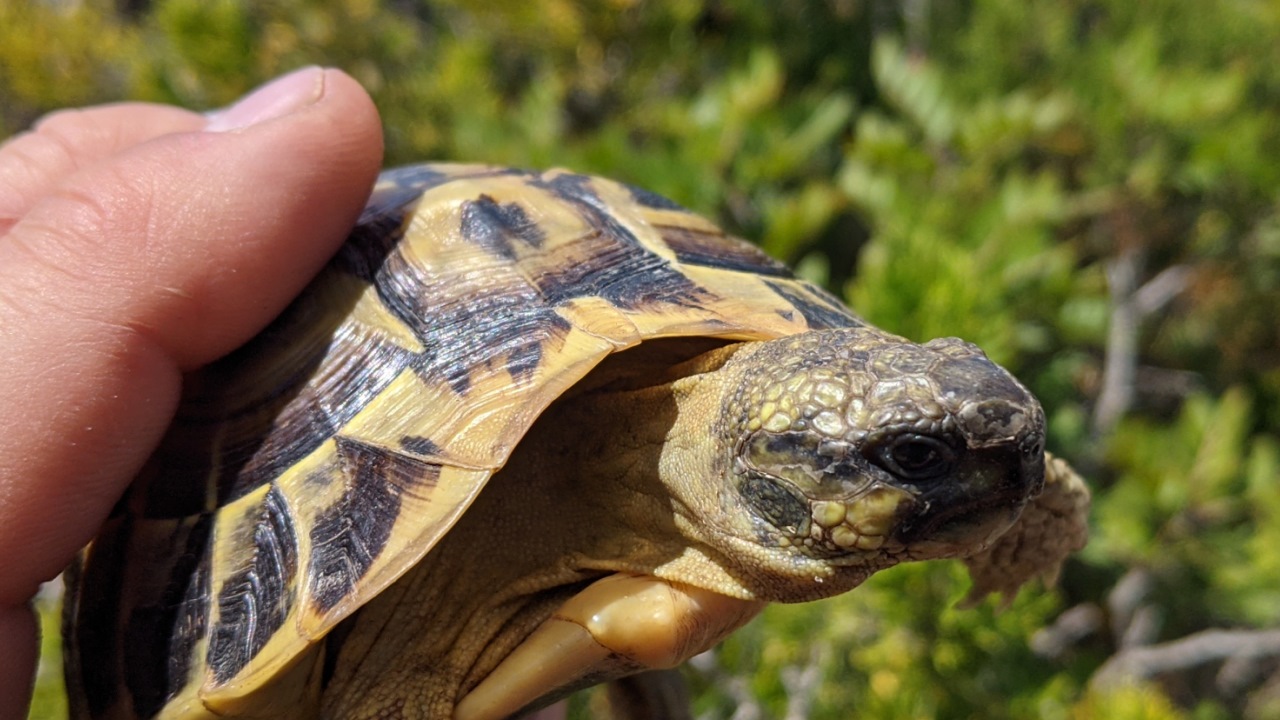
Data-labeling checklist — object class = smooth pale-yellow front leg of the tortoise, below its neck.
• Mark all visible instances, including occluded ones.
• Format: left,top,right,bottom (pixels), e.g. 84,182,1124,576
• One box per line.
454,574,764,720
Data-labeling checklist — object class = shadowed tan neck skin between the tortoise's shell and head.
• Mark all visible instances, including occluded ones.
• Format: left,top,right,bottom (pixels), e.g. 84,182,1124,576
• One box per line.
313,348,744,717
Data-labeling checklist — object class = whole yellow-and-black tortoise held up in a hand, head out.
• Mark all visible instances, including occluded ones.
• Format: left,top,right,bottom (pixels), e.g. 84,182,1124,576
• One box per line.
65,164,1088,720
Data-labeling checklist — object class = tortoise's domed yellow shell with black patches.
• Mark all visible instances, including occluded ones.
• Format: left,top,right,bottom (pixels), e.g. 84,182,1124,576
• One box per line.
60,165,861,716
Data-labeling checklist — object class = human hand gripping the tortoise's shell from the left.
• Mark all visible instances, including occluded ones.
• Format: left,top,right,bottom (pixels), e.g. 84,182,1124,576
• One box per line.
0,68,381,717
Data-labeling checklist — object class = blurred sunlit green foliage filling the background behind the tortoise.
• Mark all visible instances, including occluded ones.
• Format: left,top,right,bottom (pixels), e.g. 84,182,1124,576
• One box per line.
12,0,1280,720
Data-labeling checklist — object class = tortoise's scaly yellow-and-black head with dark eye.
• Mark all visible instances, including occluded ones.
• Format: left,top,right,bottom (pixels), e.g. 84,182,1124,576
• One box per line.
665,328,1044,601
